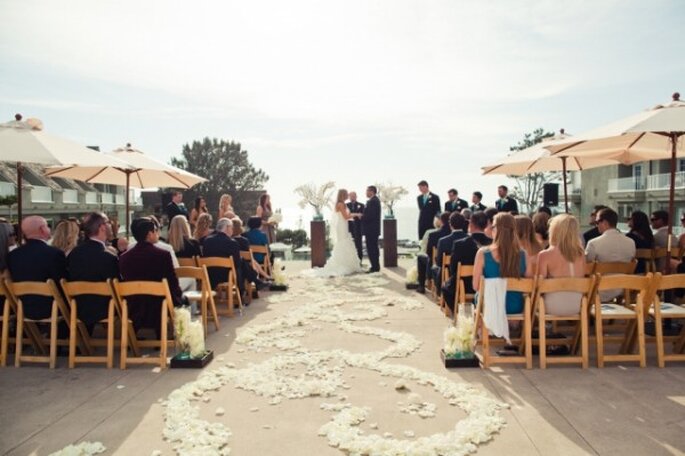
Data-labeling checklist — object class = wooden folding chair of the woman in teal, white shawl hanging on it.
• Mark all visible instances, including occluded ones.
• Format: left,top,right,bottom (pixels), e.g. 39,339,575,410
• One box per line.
476,277,535,369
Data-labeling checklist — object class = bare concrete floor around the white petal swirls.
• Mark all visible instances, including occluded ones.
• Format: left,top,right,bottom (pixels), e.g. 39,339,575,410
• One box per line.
0,263,685,455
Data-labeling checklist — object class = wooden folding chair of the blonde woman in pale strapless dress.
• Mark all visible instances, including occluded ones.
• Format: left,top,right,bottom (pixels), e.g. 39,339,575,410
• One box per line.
533,276,596,369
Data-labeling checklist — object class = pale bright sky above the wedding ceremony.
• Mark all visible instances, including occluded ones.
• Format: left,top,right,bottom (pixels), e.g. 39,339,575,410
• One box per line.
0,0,685,228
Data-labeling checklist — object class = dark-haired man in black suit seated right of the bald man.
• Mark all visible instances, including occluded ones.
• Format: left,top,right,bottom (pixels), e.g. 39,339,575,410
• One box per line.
67,212,119,334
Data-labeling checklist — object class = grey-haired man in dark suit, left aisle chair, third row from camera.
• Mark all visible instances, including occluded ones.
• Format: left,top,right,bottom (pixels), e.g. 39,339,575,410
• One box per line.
202,218,245,295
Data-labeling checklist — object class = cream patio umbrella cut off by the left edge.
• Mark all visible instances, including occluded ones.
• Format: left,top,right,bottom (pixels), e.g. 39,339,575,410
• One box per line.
0,114,133,235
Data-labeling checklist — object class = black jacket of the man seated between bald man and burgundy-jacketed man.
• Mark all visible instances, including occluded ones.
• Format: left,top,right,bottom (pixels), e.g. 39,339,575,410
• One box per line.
67,239,119,325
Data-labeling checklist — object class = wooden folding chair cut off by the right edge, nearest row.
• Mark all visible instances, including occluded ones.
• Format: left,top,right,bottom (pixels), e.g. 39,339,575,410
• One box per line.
648,274,685,367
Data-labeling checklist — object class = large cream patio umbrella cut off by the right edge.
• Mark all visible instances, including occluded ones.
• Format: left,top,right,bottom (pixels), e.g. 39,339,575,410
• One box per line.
545,92,685,251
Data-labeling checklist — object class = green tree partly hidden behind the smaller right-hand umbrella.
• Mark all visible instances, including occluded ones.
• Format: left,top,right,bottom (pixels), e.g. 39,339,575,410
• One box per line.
508,128,561,211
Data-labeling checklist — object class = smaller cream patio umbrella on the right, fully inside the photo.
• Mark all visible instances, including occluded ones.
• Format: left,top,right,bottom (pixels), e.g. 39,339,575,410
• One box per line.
481,128,615,212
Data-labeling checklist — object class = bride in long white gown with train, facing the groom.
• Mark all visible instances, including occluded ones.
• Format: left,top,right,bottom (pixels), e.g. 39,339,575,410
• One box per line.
306,188,362,277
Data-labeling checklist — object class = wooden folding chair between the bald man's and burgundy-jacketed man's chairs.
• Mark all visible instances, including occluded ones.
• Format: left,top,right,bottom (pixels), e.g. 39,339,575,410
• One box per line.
61,279,116,369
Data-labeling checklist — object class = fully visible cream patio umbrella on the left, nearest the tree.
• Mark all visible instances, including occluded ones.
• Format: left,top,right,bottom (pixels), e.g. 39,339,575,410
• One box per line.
45,144,207,235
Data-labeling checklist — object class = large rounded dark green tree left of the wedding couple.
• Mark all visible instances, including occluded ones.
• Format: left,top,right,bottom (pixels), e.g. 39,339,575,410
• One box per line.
171,138,269,220
